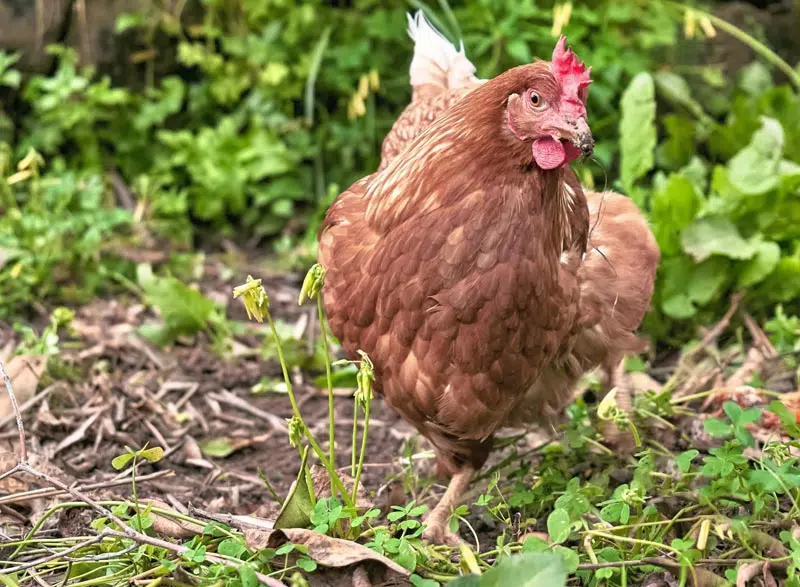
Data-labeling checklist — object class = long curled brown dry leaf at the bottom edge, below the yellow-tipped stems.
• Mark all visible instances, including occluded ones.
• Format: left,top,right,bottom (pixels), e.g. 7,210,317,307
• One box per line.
244,528,409,577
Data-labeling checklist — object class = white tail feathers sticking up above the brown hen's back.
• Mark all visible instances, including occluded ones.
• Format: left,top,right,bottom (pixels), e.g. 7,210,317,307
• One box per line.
407,10,479,89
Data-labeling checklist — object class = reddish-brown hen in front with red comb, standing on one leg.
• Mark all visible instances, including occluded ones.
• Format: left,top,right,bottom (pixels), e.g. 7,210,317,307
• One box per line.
319,25,593,542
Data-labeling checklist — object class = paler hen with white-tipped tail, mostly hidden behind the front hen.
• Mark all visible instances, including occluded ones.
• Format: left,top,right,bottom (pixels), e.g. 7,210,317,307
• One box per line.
379,11,660,448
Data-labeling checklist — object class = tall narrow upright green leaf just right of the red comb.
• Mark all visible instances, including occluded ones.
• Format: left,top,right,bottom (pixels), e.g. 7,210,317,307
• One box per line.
619,72,656,191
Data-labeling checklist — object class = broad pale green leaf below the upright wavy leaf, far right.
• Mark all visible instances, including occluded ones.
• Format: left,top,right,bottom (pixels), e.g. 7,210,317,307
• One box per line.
681,216,756,263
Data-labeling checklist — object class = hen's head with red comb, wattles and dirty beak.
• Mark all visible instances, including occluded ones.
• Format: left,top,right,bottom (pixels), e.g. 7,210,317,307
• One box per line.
504,36,594,169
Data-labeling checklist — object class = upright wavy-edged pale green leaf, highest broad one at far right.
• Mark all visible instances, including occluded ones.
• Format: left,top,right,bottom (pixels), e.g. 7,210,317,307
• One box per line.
727,117,784,195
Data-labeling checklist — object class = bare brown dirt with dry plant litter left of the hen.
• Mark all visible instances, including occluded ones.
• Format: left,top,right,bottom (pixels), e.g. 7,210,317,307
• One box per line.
0,260,432,530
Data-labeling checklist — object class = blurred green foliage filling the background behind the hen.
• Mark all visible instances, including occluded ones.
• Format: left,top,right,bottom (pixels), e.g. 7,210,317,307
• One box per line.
0,0,800,350
